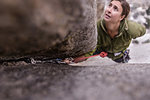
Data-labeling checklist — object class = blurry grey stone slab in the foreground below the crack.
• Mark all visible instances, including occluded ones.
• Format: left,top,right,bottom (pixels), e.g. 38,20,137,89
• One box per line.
0,62,150,100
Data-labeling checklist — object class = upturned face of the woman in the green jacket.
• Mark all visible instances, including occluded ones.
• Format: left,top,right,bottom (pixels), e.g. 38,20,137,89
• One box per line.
104,0,125,23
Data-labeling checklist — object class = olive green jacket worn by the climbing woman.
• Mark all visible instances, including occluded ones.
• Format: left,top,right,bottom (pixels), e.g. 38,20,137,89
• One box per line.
85,19,146,60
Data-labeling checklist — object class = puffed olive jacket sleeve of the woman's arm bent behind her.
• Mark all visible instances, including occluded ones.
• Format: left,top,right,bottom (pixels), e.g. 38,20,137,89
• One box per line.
128,21,146,39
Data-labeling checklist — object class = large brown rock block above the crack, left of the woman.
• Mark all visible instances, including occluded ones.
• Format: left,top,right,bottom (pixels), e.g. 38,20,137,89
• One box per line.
0,0,97,57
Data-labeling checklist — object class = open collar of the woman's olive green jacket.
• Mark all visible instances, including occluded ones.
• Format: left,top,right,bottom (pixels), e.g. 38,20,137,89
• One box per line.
100,19,128,37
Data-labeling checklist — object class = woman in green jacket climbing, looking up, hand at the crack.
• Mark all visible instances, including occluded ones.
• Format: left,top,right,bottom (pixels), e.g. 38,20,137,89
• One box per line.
64,0,146,63
